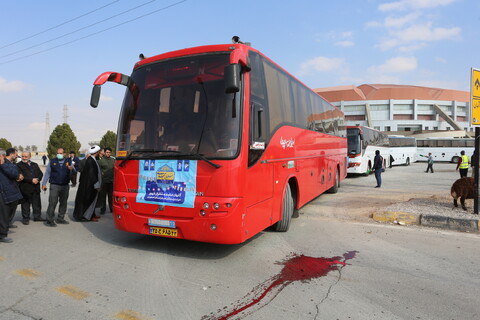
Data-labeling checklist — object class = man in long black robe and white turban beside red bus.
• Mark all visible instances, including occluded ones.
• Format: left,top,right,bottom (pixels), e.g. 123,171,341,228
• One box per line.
73,145,102,221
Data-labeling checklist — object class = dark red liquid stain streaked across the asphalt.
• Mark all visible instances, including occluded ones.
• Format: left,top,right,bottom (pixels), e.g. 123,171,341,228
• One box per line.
202,251,358,320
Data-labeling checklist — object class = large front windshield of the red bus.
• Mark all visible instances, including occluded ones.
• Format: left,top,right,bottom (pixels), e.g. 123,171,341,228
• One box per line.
118,54,241,159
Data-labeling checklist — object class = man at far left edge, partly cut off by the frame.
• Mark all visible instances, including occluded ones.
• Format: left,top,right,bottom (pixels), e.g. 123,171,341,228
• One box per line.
0,148,23,243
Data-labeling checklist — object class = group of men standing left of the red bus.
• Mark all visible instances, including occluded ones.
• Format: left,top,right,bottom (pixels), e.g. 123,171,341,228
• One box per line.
0,145,115,243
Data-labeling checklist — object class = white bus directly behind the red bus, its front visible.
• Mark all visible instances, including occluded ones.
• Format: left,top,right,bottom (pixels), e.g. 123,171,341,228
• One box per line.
347,126,390,175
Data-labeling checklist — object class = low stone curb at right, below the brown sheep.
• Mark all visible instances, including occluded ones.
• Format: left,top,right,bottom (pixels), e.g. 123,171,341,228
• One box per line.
372,211,480,232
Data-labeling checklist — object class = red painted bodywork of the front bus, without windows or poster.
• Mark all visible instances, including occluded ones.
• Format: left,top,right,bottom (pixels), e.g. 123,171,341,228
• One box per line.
104,45,347,244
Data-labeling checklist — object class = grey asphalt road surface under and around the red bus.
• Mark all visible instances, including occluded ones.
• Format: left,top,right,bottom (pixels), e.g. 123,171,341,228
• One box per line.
0,164,480,320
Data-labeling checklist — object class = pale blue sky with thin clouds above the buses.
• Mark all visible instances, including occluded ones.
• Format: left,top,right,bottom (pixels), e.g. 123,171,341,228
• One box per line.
0,0,480,150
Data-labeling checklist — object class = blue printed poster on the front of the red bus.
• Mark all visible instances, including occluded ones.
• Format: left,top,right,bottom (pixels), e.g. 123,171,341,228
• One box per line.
137,160,197,208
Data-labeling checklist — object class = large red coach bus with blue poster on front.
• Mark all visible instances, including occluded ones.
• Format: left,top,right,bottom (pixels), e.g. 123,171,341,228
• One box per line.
90,38,347,244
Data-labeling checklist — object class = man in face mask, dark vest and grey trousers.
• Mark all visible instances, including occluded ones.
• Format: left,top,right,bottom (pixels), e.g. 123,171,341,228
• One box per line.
42,148,75,227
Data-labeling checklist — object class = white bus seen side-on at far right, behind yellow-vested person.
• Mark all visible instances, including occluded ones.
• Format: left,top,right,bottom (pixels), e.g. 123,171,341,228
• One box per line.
417,138,475,163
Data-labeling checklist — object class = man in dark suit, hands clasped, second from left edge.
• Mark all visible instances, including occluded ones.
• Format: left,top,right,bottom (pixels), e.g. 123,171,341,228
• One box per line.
17,151,45,225
